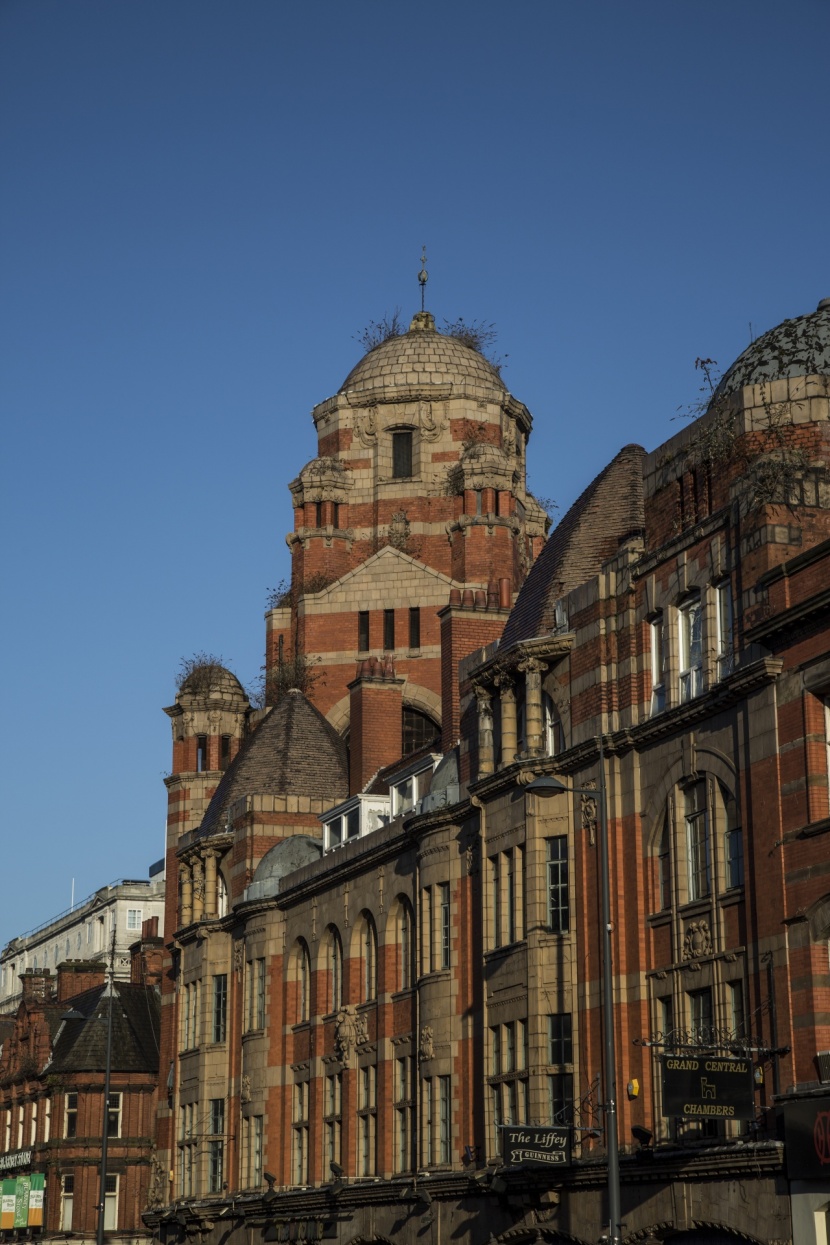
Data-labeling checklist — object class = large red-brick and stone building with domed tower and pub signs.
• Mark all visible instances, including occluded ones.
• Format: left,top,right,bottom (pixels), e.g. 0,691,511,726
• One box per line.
147,301,830,1245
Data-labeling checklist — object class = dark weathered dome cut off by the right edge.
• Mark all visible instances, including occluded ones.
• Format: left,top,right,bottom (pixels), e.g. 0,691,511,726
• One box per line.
718,299,830,396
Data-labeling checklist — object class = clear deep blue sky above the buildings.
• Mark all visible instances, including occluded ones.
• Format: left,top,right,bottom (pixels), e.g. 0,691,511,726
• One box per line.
0,0,830,944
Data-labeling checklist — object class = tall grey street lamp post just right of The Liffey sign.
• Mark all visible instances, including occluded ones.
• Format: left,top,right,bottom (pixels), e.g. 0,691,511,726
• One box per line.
525,736,622,1245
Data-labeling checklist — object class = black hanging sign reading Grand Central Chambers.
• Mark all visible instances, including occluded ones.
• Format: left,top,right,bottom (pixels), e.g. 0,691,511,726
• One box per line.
661,1055,755,1119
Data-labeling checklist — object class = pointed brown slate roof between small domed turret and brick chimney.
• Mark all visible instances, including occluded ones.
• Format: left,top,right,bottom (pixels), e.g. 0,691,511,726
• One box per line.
199,688,348,835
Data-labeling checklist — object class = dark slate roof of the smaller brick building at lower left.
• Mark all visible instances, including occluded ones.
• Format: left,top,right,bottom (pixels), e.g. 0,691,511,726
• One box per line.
49,981,161,1073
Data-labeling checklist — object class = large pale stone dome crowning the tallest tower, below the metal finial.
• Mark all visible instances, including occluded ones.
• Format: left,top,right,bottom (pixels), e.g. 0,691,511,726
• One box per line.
340,311,505,393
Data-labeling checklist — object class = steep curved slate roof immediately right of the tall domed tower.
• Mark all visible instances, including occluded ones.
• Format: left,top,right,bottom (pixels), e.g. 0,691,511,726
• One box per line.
500,446,646,649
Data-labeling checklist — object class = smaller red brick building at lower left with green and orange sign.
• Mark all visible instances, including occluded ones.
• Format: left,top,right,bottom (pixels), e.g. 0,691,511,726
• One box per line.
0,919,162,1241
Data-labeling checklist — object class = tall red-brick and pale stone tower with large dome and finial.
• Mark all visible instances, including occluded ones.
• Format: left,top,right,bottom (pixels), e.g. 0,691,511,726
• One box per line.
266,311,548,751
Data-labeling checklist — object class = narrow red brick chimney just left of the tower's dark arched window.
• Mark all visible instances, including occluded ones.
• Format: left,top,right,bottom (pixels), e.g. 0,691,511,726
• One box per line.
348,657,404,796
